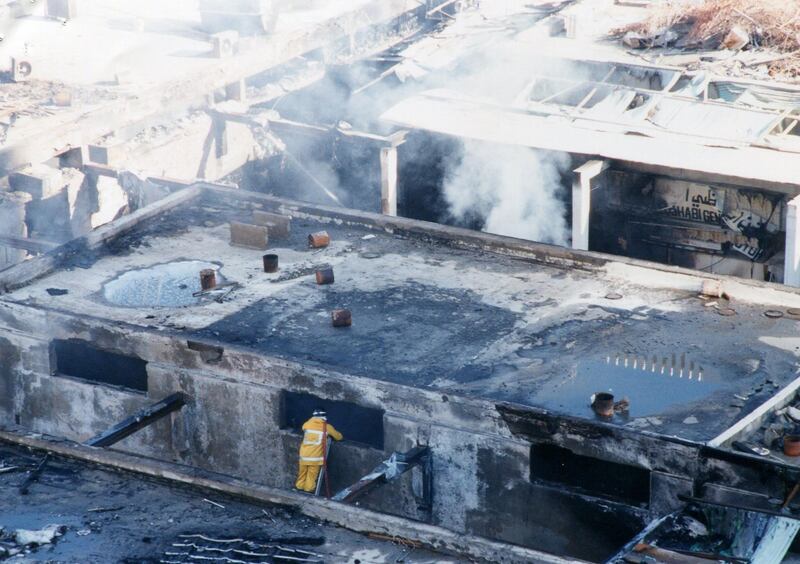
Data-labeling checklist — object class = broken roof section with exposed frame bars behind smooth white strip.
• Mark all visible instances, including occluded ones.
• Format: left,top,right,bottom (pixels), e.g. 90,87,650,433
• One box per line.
514,59,800,150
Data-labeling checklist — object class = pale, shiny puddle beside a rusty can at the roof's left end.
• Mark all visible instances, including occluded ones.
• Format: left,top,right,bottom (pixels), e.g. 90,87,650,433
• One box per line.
103,260,223,307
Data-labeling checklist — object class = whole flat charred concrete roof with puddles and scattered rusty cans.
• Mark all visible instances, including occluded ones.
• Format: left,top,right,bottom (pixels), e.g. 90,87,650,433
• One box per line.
0,186,800,442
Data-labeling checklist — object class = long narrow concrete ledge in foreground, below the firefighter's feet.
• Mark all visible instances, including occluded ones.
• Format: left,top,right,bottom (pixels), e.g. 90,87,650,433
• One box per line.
0,428,580,564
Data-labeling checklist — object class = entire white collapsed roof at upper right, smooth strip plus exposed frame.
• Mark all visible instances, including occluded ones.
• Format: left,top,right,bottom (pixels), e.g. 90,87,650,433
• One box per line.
382,41,800,194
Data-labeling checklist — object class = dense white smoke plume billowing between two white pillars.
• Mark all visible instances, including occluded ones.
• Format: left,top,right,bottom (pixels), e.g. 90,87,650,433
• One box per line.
444,141,570,245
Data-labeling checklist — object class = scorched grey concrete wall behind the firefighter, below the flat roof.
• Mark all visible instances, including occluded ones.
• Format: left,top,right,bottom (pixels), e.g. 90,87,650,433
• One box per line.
0,303,647,559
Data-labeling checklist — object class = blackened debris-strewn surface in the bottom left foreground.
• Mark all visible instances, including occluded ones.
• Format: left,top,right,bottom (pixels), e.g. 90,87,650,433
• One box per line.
0,443,460,564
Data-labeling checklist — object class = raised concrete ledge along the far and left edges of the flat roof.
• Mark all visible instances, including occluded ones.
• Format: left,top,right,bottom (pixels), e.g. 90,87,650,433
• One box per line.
9,182,800,307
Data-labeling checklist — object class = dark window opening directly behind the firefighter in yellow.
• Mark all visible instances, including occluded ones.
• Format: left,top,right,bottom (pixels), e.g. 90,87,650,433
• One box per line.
280,391,383,450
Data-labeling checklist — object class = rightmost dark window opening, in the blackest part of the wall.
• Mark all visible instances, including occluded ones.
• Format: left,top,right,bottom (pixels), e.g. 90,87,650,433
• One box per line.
531,444,650,505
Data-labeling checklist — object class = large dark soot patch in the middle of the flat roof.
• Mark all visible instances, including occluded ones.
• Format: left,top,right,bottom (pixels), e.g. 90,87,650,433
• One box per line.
201,284,517,385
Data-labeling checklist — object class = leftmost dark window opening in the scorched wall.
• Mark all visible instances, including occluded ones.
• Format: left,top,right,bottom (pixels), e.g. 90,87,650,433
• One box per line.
52,340,147,392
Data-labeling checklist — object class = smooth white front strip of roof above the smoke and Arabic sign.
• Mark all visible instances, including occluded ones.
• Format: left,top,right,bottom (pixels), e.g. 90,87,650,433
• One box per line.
382,90,800,194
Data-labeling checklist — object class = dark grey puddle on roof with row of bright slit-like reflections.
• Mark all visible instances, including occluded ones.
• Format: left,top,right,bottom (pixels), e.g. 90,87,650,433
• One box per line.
536,355,722,417
